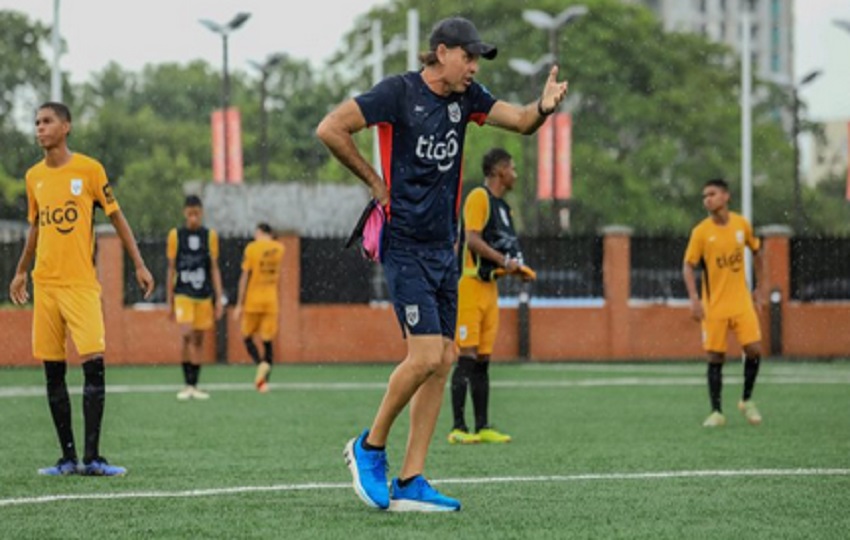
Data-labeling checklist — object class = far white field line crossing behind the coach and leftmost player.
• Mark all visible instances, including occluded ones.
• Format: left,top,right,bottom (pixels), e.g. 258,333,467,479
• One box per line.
0,374,850,399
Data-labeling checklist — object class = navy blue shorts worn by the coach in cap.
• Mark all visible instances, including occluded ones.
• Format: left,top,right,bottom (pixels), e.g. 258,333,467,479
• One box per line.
381,247,458,339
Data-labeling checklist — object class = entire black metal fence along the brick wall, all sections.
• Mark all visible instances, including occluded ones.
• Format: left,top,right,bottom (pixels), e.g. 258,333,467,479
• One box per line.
0,233,850,305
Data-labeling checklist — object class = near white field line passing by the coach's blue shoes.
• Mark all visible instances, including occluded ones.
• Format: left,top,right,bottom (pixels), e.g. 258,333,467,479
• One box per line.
0,469,850,507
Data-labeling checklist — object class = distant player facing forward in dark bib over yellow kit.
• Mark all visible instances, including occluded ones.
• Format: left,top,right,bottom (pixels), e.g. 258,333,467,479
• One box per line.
165,195,224,401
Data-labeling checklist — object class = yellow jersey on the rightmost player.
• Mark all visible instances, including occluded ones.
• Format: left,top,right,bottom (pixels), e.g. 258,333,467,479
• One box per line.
685,212,761,319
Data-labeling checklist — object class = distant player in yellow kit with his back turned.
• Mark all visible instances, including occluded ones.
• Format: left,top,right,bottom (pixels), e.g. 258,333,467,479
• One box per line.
233,223,284,392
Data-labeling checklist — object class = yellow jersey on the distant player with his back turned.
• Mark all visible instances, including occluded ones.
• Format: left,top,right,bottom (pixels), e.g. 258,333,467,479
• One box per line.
242,240,284,313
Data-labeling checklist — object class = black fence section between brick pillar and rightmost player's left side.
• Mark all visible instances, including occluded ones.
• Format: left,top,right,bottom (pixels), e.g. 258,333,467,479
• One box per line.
629,236,688,301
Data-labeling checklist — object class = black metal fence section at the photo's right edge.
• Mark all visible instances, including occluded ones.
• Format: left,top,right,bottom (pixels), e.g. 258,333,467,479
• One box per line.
789,237,850,302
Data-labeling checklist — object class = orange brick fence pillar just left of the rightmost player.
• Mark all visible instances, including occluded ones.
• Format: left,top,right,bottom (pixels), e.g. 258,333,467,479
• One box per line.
602,225,632,358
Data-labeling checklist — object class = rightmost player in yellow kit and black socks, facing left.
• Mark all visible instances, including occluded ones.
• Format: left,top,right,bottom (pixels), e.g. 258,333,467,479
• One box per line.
682,179,765,427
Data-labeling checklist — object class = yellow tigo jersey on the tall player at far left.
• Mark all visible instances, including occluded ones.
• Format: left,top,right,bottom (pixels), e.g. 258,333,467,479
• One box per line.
26,152,119,290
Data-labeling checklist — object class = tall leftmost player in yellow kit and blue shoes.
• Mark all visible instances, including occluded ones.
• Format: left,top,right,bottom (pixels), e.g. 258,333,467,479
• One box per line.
9,102,154,476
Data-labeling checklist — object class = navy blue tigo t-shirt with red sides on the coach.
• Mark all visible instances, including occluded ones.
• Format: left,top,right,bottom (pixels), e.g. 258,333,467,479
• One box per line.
354,71,496,247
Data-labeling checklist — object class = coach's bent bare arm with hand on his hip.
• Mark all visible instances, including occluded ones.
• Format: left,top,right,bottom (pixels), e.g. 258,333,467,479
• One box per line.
316,99,389,205
